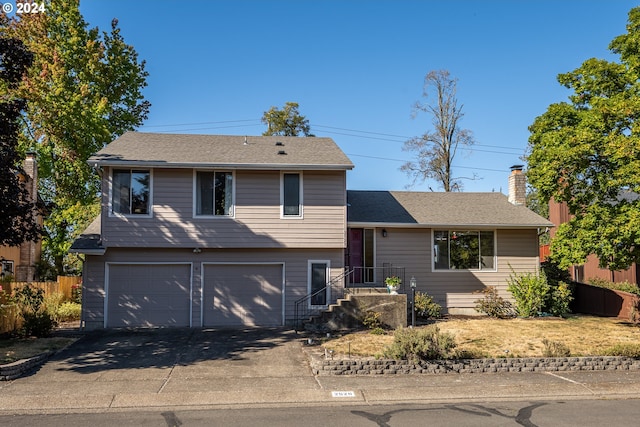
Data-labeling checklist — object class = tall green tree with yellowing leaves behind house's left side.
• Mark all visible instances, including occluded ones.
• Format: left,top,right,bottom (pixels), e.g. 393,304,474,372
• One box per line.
0,0,150,274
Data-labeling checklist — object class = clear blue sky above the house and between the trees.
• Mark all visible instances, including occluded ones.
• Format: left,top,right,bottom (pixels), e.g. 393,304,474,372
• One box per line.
80,0,638,193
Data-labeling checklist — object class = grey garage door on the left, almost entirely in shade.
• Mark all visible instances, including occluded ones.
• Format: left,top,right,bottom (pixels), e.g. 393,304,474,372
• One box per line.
107,264,191,327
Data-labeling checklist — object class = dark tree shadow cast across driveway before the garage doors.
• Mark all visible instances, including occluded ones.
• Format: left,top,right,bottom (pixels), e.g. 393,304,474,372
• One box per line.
49,328,303,373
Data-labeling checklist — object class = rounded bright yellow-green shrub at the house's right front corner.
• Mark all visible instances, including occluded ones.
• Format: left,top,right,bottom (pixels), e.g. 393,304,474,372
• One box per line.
507,270,550,317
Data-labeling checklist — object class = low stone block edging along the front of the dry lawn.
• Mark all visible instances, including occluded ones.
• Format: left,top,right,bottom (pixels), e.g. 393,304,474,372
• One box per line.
310,354,640,376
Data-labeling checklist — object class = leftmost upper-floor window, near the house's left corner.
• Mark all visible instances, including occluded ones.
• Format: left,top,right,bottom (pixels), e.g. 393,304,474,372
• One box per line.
111,169,151,215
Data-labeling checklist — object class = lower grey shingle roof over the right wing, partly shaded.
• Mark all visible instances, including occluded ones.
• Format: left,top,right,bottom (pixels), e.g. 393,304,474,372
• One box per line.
347,190,553,228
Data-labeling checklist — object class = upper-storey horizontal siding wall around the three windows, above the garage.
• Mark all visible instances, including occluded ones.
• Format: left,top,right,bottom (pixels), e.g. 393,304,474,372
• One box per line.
102,169,346,248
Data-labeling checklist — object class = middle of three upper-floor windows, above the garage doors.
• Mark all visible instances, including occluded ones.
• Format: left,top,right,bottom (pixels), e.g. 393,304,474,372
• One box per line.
196,171,234,216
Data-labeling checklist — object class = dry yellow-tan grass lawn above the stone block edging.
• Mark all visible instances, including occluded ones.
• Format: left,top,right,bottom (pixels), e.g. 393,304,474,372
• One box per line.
323,316,640,357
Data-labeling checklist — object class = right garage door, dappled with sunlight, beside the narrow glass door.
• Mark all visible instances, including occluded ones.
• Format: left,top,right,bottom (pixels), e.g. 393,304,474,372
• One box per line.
203,264,283,326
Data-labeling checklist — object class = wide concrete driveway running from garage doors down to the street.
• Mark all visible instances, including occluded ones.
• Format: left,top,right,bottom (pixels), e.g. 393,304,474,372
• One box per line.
0,328,320,410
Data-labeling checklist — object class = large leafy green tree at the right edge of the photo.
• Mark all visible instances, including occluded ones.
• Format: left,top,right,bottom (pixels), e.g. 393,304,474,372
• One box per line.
527,8,640,270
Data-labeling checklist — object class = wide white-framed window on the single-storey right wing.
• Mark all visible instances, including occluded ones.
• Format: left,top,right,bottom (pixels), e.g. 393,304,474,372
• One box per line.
433,230,496,270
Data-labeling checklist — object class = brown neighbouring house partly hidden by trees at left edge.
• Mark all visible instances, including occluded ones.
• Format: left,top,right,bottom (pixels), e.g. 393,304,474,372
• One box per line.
0,152,42,282
